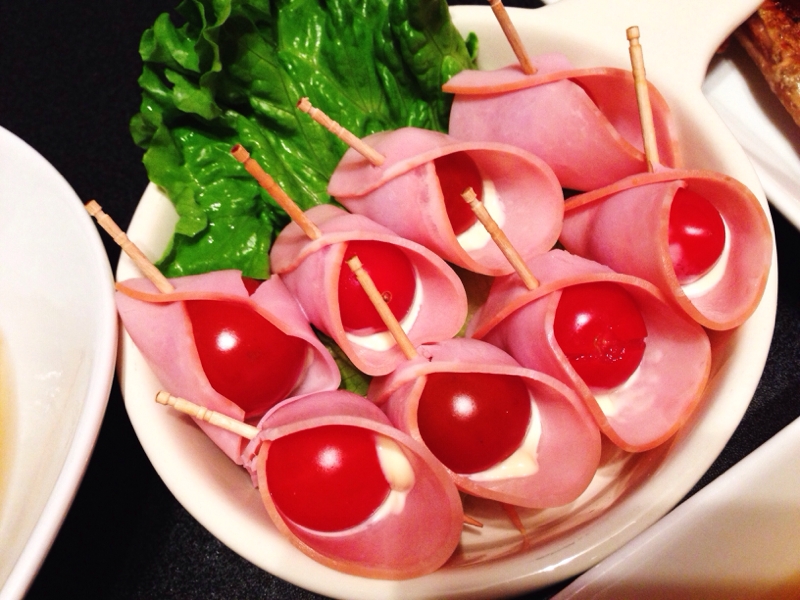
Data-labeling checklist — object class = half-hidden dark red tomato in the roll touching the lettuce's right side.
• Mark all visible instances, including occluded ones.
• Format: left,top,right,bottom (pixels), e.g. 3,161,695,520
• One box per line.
433,152,483,235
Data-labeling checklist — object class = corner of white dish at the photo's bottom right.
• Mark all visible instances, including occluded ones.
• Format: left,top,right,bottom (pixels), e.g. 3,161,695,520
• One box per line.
553,419,800,600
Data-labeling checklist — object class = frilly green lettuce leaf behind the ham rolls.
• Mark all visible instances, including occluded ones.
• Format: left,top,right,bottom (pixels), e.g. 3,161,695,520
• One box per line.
131,0,477,278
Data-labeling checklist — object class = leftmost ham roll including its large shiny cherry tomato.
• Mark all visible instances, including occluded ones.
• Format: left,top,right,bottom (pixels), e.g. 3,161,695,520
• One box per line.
116,270,341,463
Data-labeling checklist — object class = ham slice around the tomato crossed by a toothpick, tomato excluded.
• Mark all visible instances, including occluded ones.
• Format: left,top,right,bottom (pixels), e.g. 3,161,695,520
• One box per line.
270,205,467,375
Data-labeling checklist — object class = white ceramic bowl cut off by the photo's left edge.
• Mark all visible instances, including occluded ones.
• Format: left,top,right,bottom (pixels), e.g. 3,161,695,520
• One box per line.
0,128,117,600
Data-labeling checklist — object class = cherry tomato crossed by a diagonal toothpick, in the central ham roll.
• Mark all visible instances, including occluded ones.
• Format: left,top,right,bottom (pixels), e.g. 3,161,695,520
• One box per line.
339,240,417,334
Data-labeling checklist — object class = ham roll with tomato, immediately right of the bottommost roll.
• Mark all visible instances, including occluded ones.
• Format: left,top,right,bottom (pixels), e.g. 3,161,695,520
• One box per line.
368,338,600,508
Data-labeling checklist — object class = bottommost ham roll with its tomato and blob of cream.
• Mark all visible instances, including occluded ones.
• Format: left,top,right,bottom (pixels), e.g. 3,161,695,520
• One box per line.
238,390,464,579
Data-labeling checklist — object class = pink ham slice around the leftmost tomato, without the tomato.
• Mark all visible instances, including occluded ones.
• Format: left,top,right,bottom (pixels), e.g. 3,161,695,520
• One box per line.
116,270,341,463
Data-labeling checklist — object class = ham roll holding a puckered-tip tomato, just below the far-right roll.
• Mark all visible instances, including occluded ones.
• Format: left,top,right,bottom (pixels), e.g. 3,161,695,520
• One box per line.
467,250,711,452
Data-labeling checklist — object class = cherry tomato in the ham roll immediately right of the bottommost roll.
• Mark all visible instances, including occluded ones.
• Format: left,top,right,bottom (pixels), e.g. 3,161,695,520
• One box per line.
417,373,531,473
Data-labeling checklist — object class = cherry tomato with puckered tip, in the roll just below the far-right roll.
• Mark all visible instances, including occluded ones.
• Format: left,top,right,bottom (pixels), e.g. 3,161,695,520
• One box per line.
553,282,647,389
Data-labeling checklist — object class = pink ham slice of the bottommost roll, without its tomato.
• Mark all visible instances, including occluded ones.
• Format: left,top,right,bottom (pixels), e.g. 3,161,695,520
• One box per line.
238,390,464,579
